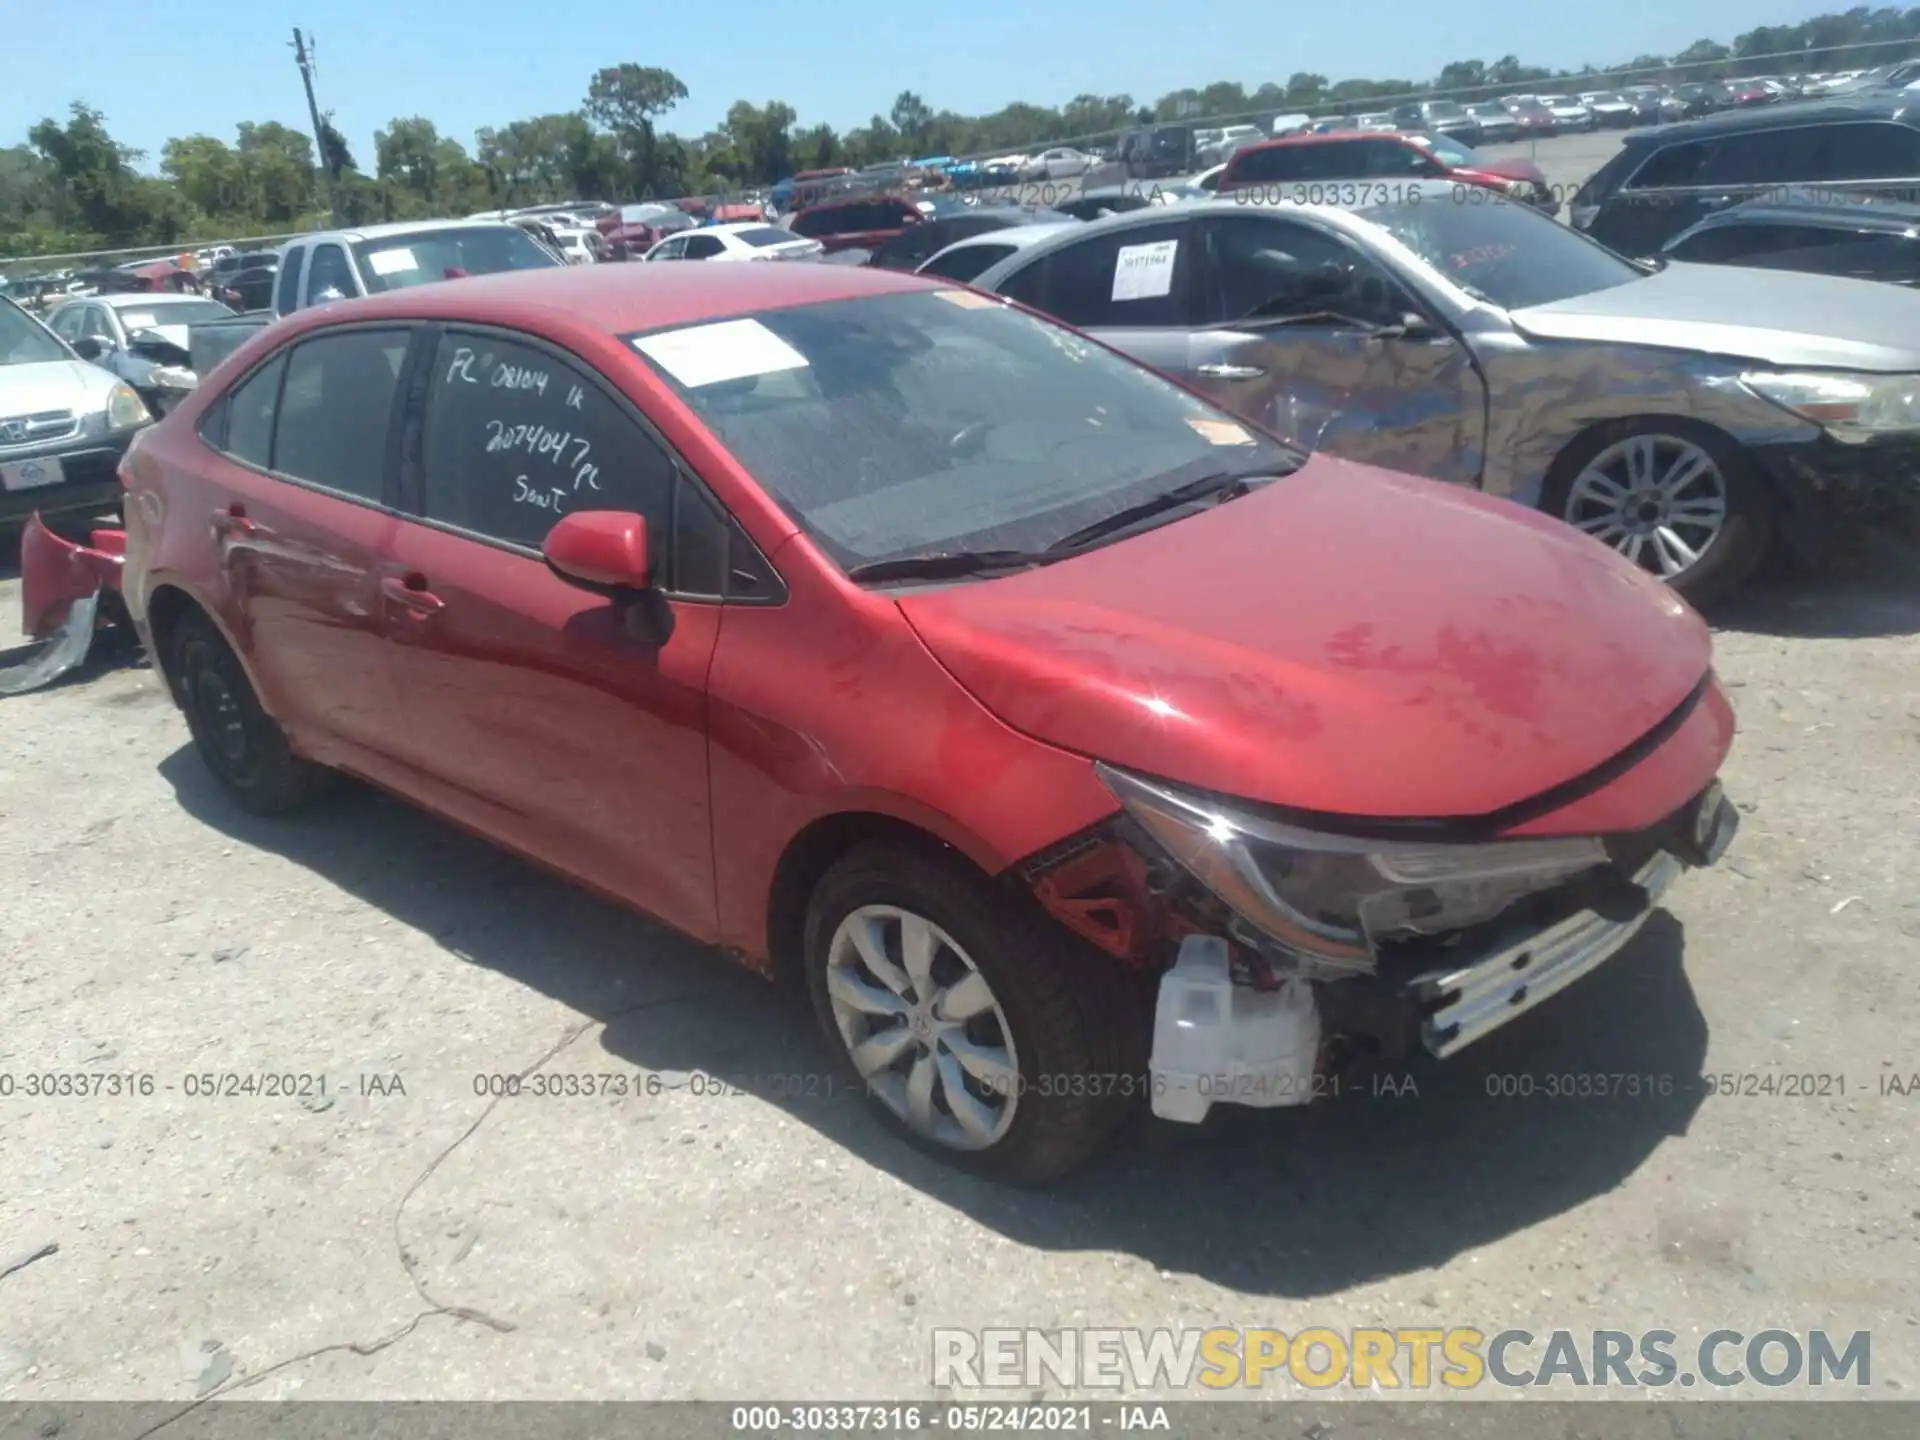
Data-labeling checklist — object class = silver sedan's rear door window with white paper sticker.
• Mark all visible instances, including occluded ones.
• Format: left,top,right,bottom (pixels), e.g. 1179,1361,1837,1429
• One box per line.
998,219,1194,328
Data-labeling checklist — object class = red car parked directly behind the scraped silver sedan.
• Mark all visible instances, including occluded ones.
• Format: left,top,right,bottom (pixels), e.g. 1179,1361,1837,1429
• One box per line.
1217,131,1559,215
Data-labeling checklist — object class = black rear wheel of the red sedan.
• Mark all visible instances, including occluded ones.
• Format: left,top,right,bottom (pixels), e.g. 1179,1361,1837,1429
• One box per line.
167,614,332,816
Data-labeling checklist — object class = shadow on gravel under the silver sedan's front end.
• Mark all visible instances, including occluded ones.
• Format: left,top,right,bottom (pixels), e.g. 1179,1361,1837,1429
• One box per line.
1707,532,1920,639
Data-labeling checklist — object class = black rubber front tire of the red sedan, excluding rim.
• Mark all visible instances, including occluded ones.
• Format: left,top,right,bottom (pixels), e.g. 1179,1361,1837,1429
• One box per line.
804,843,1150,1185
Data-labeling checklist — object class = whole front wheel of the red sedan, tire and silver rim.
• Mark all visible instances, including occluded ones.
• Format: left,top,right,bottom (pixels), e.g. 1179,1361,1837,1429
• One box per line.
806,843,1146,1185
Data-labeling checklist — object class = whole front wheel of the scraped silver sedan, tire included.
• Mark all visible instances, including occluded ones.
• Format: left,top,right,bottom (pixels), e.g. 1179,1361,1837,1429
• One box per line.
1542,419,1774,605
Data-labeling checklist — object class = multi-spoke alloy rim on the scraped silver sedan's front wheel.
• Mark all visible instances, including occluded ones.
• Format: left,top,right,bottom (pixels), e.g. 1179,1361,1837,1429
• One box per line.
1565,434,1726,580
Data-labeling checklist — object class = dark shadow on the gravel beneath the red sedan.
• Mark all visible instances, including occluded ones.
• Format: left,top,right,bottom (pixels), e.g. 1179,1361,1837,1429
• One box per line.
159,747,1707,1298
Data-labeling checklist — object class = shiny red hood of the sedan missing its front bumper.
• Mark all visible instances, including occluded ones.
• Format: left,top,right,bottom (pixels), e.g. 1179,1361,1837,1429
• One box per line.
899,457,1711,818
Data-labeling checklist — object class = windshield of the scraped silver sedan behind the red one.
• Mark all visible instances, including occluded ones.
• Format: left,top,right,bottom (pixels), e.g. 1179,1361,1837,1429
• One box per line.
1357,196,1644,309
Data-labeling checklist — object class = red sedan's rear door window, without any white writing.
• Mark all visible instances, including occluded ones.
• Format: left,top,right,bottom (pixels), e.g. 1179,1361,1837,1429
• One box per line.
273,328,413,501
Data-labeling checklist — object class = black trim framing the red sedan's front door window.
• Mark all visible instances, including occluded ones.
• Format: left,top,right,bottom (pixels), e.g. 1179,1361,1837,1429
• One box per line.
392,321,789,607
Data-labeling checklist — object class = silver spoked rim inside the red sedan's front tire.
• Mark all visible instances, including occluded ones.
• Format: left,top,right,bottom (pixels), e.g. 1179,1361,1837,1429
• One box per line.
826,904,1020,1150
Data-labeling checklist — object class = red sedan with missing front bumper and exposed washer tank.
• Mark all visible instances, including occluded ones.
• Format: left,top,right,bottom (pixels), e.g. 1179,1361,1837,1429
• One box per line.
101,265,1734,1183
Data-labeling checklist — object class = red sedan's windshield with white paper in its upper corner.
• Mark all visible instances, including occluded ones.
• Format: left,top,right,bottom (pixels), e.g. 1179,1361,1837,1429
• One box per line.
628,290,1300,568
